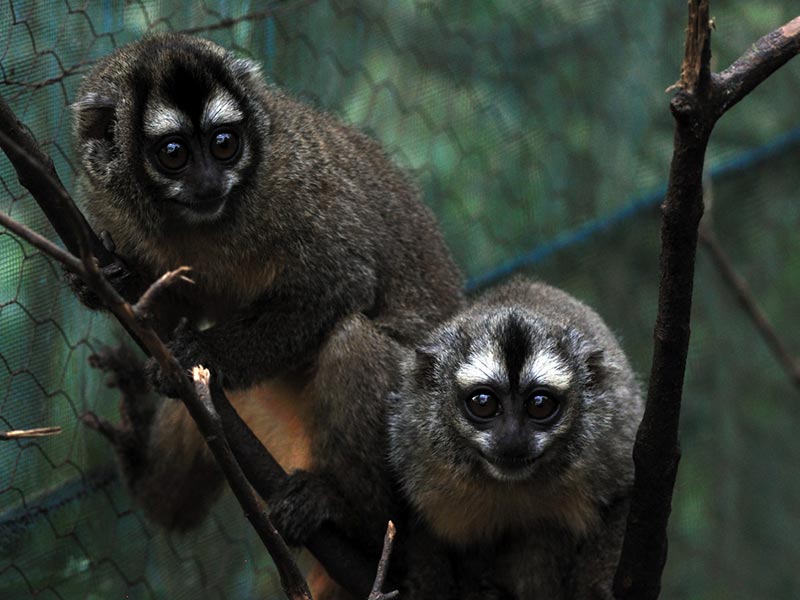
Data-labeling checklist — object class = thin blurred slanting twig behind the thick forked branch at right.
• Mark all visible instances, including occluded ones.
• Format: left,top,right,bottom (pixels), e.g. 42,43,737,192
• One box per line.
699,225,800,388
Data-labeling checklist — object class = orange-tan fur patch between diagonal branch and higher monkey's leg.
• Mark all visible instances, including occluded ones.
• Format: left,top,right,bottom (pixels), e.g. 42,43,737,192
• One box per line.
226,381,311,473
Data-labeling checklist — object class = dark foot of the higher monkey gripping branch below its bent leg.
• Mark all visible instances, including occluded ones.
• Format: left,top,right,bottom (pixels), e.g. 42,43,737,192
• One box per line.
268,471,353,546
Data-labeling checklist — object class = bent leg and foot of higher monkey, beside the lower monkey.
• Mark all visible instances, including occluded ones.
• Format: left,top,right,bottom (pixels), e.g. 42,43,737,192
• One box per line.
270,314,401,598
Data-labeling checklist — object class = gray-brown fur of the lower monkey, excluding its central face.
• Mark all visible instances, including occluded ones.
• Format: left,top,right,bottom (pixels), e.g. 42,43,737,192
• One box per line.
390,280,643,600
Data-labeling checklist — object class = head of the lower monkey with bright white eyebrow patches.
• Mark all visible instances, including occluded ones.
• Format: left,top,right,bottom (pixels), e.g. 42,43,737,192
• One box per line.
410,309,598,482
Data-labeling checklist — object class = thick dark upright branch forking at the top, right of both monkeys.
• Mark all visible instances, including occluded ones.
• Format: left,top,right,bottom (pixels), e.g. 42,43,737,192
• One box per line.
614,0,800,600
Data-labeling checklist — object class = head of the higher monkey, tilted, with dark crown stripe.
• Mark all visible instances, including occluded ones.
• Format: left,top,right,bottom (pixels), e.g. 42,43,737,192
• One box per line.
76,35,269,237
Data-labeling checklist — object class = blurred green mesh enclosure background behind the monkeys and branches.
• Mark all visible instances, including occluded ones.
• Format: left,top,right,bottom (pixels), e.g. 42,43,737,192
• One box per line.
0,0,800,600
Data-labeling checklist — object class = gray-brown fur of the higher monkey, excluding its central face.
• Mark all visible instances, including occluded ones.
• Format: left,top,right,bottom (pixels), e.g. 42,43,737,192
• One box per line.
75,34,461,592
